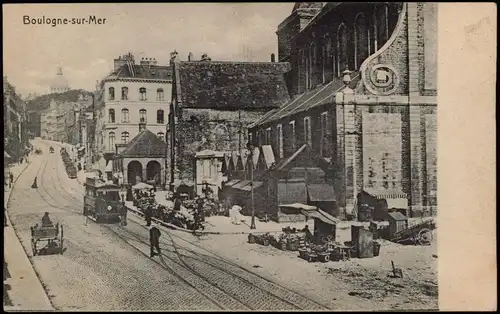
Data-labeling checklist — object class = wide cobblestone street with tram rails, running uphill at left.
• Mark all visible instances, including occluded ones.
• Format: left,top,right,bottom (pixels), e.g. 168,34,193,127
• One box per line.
8,142,327,311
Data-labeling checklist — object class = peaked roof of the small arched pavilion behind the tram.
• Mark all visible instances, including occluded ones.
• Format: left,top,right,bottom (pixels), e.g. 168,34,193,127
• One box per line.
118,129,166,158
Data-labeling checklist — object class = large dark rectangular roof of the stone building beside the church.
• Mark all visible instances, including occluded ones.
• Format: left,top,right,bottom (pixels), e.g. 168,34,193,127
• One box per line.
174,61,290,110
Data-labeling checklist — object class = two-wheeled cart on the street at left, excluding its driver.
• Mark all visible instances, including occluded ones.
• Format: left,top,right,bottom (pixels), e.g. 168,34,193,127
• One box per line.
31,223,64,256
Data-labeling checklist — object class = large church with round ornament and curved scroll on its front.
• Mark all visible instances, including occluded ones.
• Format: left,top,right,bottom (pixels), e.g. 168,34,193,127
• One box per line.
250,2,437,215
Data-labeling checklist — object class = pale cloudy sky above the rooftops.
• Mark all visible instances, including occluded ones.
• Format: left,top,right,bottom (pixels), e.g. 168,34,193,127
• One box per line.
3,2,294,96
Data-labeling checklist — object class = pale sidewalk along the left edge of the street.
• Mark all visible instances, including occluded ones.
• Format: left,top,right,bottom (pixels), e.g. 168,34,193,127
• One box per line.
4,155,54,311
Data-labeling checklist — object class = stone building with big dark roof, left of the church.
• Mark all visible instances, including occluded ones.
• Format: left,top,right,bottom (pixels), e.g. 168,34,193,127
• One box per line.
167,52,289,190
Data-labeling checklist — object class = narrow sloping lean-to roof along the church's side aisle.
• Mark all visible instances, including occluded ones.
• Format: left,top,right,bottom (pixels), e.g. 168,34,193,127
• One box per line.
249,72,360,128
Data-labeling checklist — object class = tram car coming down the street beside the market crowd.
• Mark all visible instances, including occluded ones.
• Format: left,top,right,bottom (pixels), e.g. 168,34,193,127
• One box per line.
83,178,126,223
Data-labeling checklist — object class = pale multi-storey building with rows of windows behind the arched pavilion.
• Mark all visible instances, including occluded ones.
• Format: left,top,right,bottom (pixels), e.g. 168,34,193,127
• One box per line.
95,54,172,169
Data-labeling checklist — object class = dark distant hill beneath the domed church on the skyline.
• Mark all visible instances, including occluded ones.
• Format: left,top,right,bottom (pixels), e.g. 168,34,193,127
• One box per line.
26,89,92,136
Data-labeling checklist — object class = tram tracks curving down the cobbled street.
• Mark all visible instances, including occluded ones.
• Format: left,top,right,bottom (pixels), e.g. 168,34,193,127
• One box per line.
37,143,327,310
